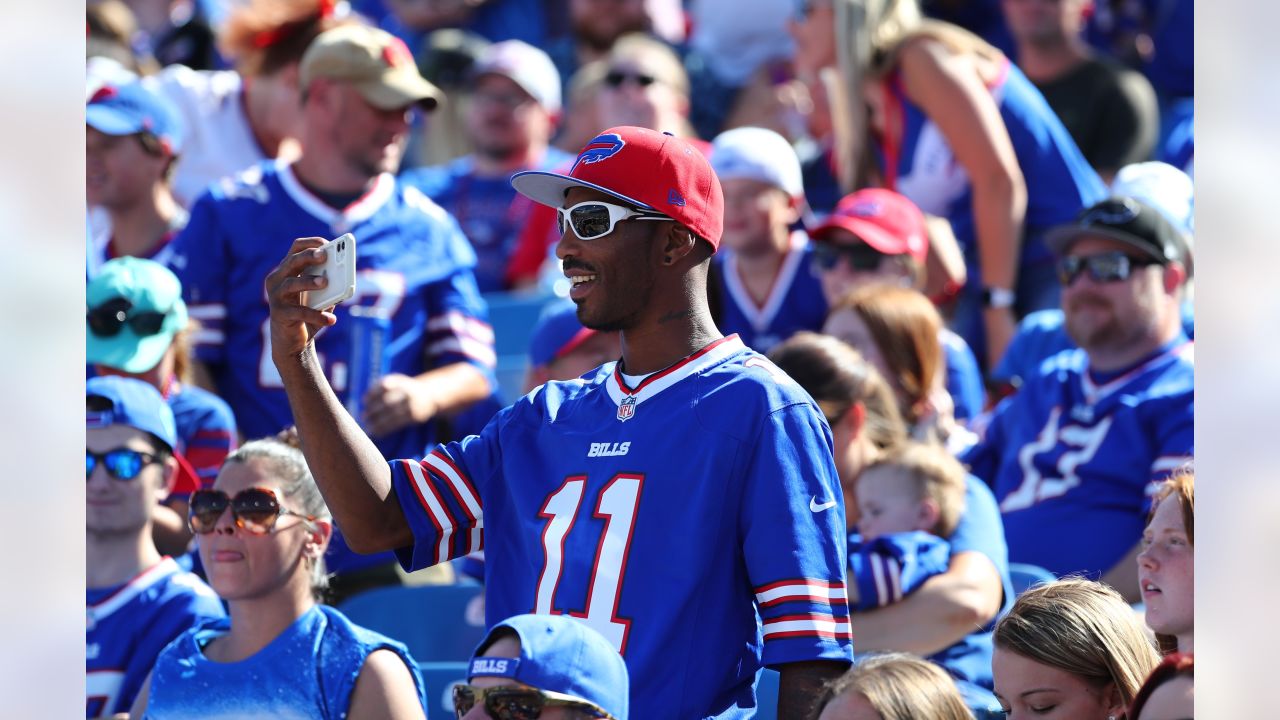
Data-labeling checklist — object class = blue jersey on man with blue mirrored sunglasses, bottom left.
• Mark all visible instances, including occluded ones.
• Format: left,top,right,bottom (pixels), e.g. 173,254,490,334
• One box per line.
84,557,225,717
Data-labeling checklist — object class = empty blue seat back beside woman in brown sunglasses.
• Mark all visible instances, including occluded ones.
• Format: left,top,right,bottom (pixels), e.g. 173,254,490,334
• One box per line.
338,585,485,664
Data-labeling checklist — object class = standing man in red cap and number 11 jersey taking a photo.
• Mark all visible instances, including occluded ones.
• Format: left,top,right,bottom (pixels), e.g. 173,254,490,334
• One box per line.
266,127,852,719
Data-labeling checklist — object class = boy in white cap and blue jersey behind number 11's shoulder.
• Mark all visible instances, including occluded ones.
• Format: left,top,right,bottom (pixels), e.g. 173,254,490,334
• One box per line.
708,127,827,352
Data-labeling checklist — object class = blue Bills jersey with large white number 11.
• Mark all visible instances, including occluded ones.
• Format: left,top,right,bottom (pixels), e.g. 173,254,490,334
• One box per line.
390,337,852,717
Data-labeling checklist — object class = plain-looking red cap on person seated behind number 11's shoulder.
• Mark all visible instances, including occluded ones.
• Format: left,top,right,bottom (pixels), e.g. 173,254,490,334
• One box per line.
809,187,929,263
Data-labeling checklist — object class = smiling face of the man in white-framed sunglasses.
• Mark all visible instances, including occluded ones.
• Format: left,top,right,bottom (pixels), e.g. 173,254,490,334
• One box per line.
556,187,669,331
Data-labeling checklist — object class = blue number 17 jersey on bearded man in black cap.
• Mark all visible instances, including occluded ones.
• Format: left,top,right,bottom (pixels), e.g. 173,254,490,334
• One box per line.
964,336,1196,578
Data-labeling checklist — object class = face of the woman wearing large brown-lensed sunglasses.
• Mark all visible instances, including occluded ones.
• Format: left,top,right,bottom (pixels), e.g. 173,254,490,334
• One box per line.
200,459,324,601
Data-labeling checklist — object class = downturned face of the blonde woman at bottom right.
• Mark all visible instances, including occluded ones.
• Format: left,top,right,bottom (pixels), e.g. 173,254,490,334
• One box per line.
991,644,1123,720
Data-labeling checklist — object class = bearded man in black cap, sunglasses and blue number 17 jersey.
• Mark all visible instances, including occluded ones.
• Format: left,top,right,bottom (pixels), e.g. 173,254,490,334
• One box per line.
964,197,1194,602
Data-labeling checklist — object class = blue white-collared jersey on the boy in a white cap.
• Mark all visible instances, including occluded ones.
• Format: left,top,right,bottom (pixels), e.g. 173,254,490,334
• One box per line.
710,232,827,352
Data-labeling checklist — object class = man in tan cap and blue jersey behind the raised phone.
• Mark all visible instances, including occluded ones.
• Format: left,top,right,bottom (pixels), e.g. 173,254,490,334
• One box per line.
173,26,494,457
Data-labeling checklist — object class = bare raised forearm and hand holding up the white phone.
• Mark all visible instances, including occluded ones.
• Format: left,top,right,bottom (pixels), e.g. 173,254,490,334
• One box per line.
265,237,413,552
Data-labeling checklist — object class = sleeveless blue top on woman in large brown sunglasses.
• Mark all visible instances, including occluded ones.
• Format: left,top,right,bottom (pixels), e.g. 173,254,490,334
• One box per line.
145,605,426,720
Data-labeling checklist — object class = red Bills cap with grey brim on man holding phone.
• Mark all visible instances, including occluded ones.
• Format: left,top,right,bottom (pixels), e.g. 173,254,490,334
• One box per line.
511,126,724,249
